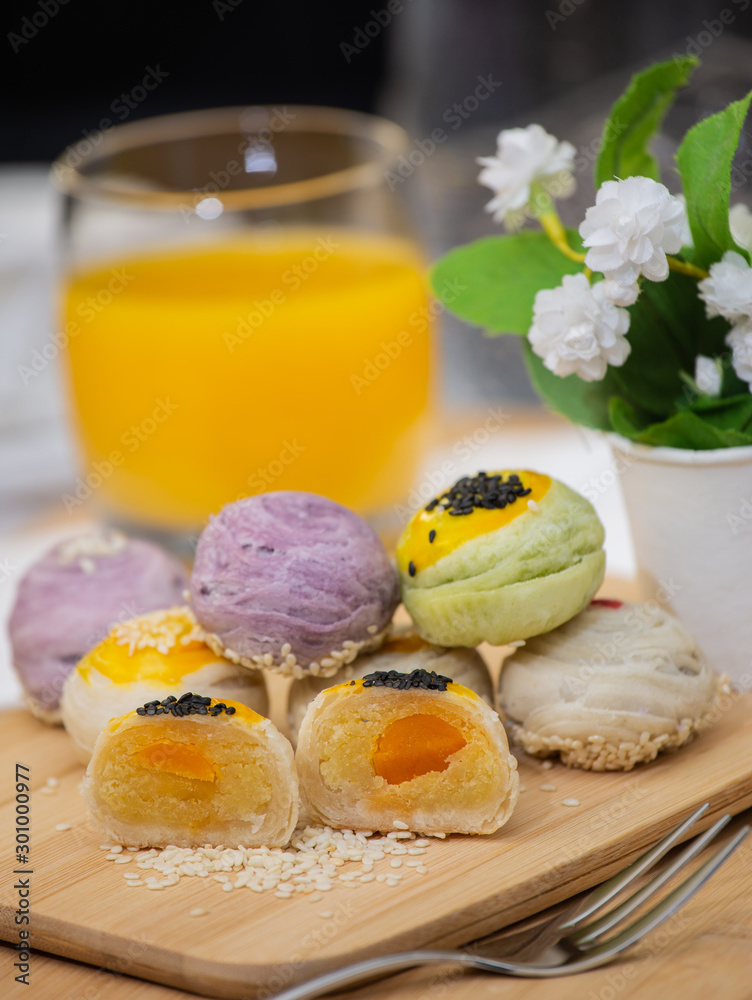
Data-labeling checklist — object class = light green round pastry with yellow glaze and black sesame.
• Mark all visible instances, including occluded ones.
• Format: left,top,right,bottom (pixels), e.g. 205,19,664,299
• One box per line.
397,470,605,646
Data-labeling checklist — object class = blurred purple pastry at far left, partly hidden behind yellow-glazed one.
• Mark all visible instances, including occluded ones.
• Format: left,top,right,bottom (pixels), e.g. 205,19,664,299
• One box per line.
8,531,187,723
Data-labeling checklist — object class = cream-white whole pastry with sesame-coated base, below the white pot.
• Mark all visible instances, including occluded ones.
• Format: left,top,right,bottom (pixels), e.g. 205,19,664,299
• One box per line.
499,601,723,771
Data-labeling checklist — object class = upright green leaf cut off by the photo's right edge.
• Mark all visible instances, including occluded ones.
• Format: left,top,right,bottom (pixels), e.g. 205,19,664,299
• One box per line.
676,92,752,268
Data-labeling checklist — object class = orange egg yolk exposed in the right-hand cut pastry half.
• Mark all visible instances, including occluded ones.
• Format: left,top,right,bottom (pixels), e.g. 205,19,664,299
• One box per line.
372,715,467,785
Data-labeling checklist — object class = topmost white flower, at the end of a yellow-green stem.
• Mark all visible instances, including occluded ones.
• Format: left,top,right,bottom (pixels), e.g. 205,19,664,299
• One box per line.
477,125,575,229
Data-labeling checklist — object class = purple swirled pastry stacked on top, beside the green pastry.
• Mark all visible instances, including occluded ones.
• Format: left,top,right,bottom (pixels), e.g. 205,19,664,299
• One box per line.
190,491,399,677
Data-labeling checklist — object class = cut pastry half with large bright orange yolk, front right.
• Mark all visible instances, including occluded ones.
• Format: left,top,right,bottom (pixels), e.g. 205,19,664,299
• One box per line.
296,670,519,833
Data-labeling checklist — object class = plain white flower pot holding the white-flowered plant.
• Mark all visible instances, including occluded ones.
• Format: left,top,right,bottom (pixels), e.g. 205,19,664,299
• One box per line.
606,434,752,690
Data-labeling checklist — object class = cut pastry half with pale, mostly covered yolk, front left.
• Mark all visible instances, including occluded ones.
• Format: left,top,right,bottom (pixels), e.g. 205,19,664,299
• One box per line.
82,693,298,847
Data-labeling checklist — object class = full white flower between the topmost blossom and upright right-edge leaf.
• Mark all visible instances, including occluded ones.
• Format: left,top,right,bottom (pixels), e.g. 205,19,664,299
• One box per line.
580,177,687,285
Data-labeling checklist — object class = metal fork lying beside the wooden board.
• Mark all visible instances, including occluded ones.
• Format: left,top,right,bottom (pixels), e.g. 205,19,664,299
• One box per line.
275,802,750,1000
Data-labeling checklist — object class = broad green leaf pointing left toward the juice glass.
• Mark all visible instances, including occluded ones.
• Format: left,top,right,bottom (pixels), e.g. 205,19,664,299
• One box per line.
430,230,582,334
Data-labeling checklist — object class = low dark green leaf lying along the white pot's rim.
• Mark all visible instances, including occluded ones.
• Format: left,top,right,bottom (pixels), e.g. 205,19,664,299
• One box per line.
609,397,752,451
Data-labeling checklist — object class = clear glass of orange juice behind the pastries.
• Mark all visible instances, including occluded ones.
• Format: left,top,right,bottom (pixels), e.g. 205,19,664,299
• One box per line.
53,106,431,552
